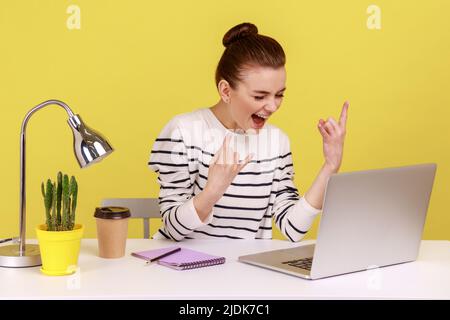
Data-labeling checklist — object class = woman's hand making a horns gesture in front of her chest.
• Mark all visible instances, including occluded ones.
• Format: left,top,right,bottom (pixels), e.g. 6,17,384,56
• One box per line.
205,134,253,198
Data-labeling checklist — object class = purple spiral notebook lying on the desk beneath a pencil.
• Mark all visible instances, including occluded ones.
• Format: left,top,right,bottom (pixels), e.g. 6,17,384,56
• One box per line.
131,247,225,270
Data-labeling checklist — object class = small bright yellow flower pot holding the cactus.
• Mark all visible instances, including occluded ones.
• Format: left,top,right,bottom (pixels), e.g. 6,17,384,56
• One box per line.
36,224,84,276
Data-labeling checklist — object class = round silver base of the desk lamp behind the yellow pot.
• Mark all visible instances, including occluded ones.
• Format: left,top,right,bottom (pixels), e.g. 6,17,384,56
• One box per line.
0,244,42,268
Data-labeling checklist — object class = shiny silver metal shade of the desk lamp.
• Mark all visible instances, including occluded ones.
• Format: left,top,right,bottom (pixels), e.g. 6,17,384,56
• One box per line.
67,114,114,168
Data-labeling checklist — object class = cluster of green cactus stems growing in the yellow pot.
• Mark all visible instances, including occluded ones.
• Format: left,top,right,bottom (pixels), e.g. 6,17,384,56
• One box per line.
41,172,78,231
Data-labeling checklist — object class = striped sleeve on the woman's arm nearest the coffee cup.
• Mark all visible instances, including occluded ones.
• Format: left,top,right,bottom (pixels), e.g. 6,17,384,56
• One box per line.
148,117,212,241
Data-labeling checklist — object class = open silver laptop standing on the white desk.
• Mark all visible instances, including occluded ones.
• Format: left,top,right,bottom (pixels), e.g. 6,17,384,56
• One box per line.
239,163,437,280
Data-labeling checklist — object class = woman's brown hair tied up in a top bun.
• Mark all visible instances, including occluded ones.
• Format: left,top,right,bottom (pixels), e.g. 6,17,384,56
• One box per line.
216,22,286,89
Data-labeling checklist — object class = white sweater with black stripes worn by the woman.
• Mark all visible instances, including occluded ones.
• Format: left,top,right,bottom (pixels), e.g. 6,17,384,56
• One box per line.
148,108,320,242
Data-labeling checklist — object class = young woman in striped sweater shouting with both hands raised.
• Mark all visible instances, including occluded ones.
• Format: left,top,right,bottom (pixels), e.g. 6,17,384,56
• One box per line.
149,23,348,241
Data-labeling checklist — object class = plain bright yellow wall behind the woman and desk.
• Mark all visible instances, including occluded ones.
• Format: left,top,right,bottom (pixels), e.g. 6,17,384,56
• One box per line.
0,0,450,239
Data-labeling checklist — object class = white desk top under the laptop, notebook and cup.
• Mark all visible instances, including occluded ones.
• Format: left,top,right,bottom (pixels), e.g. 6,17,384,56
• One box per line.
0,239,450,300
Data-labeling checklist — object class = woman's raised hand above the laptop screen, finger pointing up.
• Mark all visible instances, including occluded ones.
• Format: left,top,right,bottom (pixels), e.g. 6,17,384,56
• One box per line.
318,101,349,173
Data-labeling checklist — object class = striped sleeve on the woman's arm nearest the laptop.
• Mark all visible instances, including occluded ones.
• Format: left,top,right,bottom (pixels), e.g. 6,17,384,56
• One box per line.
272,136,321,242
